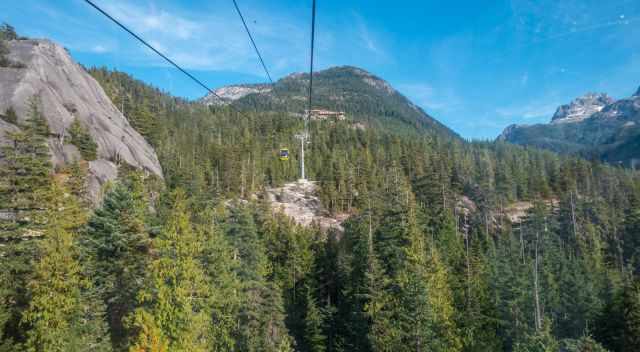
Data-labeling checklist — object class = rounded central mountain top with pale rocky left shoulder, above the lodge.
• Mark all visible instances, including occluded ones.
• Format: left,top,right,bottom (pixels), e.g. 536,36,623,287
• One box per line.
200,66,459,138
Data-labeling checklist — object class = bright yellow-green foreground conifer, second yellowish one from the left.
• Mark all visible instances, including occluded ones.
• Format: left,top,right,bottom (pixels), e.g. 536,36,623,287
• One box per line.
127,190,211,352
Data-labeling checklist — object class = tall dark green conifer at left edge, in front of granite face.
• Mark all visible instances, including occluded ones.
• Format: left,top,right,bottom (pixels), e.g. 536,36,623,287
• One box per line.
0,98,54,350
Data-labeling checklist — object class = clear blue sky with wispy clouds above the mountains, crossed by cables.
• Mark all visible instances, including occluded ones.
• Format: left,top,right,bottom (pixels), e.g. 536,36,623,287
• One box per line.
0,0,640,139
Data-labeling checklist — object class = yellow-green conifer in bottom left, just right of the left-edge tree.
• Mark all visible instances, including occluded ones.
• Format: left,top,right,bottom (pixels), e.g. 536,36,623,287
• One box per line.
23,219,111,352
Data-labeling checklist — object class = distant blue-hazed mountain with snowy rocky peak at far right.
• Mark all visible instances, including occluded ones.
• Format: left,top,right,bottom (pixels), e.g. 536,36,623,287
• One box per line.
499,89,640,167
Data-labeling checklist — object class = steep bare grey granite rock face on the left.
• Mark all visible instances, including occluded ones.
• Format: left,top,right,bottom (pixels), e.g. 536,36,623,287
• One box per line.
0,40,162,200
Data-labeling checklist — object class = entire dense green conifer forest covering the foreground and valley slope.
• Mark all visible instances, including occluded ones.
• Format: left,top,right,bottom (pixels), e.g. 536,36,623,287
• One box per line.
0,69,640,351
